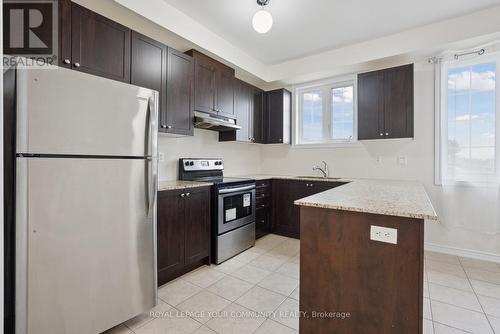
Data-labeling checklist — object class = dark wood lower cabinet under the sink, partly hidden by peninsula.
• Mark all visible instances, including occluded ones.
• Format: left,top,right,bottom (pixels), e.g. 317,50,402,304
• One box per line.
271,180,344,239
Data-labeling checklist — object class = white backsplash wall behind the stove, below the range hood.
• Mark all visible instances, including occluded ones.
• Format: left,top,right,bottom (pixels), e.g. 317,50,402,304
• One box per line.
158,129,261,180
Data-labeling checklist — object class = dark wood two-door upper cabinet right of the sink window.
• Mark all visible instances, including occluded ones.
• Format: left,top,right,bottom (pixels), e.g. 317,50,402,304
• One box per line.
358,64,413,140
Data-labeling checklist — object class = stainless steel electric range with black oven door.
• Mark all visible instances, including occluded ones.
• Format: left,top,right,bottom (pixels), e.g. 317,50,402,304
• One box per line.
179,158,255,264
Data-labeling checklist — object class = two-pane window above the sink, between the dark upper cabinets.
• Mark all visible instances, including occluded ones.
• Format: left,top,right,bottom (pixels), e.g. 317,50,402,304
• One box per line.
296,81,356,145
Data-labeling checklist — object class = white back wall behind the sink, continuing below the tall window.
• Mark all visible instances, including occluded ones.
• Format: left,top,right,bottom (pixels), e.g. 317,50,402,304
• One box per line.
262,62,500,259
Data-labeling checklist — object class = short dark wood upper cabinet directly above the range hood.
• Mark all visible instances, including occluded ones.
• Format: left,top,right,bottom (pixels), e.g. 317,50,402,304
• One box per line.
186,49,235,118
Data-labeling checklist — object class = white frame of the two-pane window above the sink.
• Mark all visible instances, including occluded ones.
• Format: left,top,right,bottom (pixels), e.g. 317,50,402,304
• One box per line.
292,75,359,148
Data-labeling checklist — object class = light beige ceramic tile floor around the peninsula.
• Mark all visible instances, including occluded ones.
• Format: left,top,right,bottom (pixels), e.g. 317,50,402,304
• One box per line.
101,235,500,334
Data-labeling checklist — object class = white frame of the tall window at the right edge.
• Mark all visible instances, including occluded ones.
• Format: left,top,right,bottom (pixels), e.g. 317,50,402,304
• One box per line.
435,53,500,186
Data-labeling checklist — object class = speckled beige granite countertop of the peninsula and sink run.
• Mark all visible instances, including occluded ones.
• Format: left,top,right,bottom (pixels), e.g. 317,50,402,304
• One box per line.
230,174,438,220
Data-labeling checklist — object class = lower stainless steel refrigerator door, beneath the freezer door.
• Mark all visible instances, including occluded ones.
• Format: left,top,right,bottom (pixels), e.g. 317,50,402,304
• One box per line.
16,158,156,334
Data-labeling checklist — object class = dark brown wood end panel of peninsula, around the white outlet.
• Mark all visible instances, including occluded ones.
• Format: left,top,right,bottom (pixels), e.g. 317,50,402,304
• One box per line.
300,207,424,334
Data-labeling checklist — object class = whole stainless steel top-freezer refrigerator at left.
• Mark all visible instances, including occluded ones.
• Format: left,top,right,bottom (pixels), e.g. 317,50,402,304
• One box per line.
15,68,158,334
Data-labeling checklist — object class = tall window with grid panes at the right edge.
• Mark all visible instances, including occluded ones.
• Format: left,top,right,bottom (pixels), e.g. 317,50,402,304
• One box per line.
441,56,500,183
